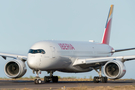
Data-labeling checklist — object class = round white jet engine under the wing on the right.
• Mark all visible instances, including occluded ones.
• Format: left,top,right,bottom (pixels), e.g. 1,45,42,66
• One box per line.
103,60,126,79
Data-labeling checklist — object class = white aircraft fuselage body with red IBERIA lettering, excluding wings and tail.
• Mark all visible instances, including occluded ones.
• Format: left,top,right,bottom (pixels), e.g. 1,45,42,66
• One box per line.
27,40,112,73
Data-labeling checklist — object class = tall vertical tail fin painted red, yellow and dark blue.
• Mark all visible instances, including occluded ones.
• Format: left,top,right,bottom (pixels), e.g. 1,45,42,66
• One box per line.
102,5,113,45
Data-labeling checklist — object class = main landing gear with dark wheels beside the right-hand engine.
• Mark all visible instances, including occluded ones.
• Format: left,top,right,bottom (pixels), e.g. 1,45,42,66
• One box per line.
93,66,108,83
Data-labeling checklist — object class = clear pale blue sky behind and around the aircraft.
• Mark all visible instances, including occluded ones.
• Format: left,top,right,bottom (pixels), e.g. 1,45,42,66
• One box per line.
0,0,135,79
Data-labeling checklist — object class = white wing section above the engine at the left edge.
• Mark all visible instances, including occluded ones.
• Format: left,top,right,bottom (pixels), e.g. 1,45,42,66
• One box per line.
0,53,27,61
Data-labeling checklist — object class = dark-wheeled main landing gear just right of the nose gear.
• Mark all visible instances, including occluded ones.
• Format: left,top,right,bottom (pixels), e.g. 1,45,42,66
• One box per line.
44,71,58,83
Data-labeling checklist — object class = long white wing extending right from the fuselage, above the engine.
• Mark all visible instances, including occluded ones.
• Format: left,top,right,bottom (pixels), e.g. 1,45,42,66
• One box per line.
73,55,135,66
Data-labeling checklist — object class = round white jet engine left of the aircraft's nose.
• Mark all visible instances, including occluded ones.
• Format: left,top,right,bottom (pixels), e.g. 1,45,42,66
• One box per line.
4,60,27,78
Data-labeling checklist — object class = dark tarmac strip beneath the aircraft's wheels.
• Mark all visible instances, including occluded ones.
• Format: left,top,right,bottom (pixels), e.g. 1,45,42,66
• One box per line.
0,80,135,89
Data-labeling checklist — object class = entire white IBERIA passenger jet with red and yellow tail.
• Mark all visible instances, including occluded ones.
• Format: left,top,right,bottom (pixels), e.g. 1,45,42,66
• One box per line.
0,5,135,84
